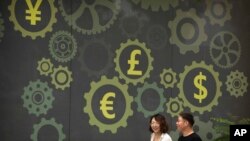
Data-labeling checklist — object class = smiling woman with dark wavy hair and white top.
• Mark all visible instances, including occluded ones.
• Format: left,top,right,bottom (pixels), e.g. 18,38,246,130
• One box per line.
149,114,172,141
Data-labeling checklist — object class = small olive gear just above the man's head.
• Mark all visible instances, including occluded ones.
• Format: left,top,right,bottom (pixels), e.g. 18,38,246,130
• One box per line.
166,97,184,117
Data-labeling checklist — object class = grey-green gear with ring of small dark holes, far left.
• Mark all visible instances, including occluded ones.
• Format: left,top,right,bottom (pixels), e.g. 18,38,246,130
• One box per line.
21,79,55,116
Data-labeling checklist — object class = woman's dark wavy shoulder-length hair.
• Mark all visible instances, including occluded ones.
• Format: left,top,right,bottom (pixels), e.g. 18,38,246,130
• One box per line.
149,114,169,133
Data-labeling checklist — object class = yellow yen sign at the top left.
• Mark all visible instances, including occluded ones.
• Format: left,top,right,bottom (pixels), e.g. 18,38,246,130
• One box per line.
25,0,42,25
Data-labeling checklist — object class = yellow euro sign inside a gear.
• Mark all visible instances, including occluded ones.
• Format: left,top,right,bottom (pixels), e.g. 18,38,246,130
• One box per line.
100,92,115,119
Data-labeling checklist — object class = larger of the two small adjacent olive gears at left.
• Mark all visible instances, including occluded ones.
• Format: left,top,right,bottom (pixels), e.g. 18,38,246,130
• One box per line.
51,65,73,90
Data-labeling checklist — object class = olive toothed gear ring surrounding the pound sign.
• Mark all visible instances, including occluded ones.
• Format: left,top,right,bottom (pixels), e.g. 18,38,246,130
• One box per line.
114,39,154,85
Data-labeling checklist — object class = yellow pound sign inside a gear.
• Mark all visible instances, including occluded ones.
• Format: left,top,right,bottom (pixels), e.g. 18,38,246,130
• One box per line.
127,50,142,75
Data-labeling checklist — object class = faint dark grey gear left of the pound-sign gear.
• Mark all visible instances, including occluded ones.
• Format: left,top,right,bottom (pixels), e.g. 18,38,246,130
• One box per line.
78,38,114,76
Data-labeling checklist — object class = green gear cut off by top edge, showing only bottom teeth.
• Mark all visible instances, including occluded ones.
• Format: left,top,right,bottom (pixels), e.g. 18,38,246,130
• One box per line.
132,0,179,11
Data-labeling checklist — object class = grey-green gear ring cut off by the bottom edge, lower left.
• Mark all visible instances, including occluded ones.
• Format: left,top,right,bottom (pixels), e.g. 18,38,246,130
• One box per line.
30,118,66,141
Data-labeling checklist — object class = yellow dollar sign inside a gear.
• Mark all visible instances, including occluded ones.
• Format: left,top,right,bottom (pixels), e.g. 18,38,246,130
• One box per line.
194,72,207,103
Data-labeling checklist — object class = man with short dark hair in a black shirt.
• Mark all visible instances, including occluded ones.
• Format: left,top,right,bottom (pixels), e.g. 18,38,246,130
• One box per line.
176,113,202,141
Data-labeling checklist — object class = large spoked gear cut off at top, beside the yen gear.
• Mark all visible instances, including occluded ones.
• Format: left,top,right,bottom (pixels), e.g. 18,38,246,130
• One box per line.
58,0,121,35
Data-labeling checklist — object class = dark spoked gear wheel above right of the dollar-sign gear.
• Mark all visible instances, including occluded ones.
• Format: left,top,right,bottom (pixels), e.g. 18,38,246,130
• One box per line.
209,31,241,69
